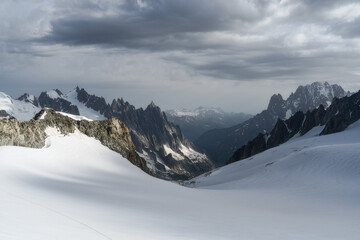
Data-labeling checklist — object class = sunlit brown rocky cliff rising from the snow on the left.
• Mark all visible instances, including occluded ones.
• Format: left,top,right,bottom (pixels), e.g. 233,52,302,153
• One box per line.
0,109,150,174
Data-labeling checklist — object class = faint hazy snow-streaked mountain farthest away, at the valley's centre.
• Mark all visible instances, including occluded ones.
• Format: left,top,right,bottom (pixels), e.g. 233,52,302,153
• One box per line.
165,107,252,141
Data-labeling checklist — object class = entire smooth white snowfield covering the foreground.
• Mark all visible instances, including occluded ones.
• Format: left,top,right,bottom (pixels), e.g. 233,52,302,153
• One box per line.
0,122,360,240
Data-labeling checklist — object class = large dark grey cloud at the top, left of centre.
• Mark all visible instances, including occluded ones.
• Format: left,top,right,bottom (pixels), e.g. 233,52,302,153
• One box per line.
38,0,267,51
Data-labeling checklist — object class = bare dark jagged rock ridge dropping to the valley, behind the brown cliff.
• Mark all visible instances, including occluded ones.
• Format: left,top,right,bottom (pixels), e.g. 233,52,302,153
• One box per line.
76,88,214,180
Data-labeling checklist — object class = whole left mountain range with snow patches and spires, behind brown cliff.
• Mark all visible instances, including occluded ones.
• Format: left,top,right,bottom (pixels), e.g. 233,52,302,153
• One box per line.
0,87,214,180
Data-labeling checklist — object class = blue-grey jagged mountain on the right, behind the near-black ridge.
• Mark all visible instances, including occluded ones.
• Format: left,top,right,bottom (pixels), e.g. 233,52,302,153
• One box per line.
195,82,349,166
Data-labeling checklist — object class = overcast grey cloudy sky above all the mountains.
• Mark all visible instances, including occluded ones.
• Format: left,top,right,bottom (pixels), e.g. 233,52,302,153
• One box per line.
0,0,360,113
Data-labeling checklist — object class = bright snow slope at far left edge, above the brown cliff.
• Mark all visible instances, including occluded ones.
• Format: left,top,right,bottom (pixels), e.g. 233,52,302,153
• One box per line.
0,92,40,121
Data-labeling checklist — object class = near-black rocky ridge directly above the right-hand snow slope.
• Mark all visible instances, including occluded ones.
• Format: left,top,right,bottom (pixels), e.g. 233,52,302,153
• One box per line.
228,91,360,163
